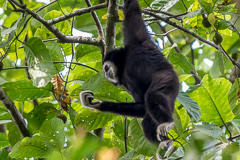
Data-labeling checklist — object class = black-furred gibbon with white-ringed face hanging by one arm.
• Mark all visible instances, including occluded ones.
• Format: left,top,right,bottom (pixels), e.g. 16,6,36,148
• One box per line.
80,0,179,143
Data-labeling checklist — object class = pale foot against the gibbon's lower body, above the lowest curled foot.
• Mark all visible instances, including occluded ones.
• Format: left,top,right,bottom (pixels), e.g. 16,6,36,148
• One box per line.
157,122,174,142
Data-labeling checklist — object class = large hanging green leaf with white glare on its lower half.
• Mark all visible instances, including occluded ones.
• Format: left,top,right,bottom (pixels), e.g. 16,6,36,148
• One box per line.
24,38,54,87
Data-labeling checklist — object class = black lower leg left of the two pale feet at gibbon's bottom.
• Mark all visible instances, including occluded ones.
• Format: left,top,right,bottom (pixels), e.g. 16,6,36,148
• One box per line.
142,114,159,143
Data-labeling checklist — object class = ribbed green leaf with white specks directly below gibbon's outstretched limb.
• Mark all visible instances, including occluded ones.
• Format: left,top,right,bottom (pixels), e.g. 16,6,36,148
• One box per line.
74,110,116,131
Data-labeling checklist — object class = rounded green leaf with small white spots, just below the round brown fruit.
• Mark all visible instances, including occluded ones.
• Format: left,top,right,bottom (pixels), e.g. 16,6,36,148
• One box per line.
40,118,65,152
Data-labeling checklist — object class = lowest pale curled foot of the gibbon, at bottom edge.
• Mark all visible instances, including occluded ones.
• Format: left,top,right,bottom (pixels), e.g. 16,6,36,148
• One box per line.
156,140,174,160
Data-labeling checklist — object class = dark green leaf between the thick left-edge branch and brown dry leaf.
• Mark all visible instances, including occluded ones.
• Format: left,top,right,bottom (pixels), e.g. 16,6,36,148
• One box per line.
26,103,60,133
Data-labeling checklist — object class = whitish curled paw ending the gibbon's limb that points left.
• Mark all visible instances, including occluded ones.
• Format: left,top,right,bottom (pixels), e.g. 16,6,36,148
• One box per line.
79,91,101,110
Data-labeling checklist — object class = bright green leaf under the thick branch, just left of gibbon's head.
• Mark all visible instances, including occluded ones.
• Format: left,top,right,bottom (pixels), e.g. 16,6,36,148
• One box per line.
76,44,100,63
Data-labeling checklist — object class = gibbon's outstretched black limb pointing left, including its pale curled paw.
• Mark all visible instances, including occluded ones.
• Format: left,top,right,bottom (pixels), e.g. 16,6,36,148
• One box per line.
80,91,146,118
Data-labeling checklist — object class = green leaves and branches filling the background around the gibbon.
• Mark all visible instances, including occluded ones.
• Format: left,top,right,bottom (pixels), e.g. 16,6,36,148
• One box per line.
0,0,240,160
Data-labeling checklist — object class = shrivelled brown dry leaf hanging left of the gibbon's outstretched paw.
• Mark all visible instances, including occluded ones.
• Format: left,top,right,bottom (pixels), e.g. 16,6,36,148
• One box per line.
51,76,71,112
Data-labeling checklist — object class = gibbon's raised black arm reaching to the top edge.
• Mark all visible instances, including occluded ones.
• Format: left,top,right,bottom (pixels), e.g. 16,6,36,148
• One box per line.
123,0,150,46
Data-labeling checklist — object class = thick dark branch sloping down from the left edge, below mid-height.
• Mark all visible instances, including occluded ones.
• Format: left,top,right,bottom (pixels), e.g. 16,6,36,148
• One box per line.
0,87,31,137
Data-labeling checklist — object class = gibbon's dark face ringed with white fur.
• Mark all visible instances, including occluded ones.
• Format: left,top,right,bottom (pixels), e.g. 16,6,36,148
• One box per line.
103,61,119,85
